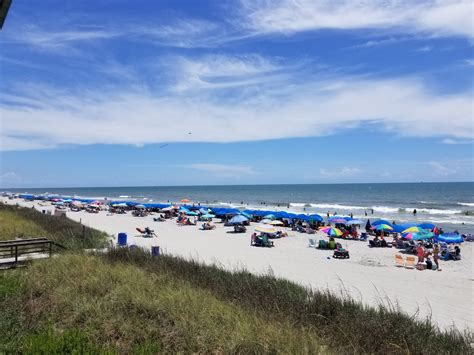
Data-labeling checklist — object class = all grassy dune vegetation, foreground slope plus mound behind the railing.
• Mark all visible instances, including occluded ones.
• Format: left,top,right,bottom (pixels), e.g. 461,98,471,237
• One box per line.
0,208,472,354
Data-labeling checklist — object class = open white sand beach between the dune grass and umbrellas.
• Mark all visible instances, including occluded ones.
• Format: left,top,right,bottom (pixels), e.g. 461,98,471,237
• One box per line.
4,199,474,330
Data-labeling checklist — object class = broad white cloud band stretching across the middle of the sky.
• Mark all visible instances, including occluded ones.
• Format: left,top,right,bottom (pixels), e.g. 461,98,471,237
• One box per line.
0,70,474,150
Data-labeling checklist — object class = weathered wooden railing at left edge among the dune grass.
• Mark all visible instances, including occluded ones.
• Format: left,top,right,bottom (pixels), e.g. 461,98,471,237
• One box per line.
0,238,66,265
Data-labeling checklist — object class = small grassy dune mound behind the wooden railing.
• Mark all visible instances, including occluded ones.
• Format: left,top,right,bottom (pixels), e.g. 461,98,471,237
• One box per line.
0,204,107,250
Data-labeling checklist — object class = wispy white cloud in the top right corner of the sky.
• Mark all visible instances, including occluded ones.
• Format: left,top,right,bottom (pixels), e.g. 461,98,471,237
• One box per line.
242,0,474,38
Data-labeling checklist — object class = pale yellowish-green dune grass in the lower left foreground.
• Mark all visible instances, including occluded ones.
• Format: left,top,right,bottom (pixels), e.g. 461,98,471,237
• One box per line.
0,254,324,353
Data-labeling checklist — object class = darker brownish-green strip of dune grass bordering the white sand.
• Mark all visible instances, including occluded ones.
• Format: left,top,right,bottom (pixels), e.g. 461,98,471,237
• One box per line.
107,249,473,354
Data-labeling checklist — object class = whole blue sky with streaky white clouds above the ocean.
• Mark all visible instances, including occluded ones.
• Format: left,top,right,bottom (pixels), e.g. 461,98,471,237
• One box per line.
0,0,474,188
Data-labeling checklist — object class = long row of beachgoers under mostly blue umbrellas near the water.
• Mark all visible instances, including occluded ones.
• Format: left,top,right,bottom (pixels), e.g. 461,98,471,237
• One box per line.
7,195,472,262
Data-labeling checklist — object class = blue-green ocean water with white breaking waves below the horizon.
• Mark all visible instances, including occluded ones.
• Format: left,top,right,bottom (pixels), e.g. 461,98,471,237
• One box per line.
4,182,474,233
